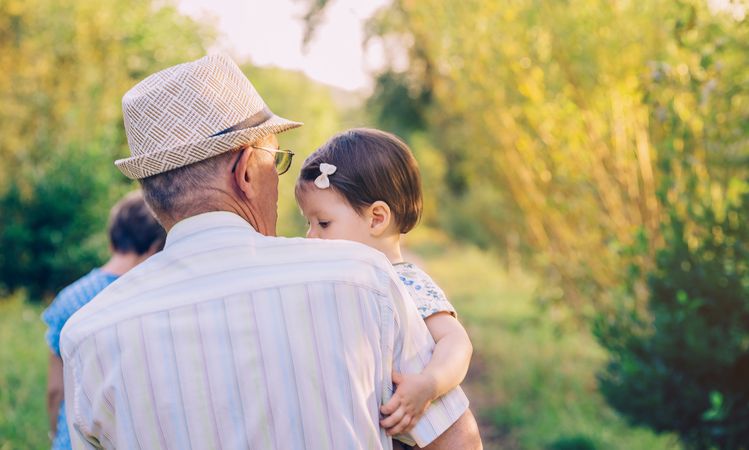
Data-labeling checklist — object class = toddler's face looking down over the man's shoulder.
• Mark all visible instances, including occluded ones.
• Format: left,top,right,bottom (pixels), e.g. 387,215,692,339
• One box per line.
298,183,372,245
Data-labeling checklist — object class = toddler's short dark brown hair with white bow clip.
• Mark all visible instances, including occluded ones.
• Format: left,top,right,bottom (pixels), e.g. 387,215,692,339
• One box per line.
296,128,423,233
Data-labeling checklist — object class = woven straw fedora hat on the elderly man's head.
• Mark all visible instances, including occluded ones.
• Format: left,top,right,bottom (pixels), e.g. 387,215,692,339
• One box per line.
115,54,302,179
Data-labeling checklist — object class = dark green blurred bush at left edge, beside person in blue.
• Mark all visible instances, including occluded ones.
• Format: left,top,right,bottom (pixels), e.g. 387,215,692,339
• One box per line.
0,148,121,301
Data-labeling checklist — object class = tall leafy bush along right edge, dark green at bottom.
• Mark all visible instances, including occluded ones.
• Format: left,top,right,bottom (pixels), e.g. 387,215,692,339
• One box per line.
596,2,749,448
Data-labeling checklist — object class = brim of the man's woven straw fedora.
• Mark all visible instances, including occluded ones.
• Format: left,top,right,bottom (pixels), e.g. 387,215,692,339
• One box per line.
114,114,303,180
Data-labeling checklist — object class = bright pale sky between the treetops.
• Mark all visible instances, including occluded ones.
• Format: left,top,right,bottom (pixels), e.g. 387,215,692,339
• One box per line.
178,0,387,90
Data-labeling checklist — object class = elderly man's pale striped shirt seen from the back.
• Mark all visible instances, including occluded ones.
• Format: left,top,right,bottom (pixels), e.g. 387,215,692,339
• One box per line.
61,212,468,450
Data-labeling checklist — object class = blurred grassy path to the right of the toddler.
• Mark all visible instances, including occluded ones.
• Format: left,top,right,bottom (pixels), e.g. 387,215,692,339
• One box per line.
407,228,679,450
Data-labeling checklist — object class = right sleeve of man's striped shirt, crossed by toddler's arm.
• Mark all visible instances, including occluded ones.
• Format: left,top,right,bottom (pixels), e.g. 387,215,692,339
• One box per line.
383,266,468,447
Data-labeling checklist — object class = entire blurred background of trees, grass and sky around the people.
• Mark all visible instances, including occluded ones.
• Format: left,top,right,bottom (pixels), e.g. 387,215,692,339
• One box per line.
0,0,749,450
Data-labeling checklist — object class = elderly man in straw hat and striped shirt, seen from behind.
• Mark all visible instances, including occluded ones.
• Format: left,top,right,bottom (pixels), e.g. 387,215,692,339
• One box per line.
61,55,481,449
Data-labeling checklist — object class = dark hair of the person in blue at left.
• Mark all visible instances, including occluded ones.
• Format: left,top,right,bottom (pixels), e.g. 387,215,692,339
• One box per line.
107,191,166,255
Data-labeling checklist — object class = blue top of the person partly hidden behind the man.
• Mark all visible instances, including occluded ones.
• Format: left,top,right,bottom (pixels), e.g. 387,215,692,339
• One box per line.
42,269,117,450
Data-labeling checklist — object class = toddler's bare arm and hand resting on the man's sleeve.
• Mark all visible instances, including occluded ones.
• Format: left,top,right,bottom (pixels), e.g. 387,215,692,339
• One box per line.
380,312,473,436
